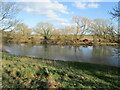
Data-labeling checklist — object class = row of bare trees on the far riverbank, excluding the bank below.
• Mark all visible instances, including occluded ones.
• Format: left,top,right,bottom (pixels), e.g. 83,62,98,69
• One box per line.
3,16,117,42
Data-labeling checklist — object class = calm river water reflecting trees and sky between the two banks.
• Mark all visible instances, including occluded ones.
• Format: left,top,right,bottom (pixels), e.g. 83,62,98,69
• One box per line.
3,44,120,66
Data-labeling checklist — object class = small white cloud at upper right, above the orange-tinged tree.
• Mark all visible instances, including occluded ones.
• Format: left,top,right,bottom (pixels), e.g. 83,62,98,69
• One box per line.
74,0,99,9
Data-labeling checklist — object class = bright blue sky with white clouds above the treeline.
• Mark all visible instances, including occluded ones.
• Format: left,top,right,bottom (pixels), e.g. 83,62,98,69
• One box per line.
17,0,118,28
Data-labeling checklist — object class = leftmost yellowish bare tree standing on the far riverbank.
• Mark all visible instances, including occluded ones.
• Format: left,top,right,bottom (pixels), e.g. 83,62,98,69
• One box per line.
3,23,32,42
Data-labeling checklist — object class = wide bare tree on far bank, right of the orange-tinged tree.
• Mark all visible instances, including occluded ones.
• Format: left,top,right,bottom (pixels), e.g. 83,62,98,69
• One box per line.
91,19,115,41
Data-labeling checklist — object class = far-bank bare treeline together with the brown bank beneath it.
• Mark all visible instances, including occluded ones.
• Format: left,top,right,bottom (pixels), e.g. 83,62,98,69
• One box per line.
3,16,119,43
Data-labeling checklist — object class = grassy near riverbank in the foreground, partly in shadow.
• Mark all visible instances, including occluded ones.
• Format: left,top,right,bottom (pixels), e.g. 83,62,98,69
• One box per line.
2,53,120,89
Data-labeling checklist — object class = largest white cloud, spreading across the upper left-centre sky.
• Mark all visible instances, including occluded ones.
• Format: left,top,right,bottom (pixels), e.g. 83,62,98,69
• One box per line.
20,0,69,22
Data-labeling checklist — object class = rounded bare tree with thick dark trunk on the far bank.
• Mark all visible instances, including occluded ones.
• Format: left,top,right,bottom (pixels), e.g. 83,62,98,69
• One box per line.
34,22,53,40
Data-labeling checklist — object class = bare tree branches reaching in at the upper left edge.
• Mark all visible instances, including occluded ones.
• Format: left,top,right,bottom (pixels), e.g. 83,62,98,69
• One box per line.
0,1,19,31
